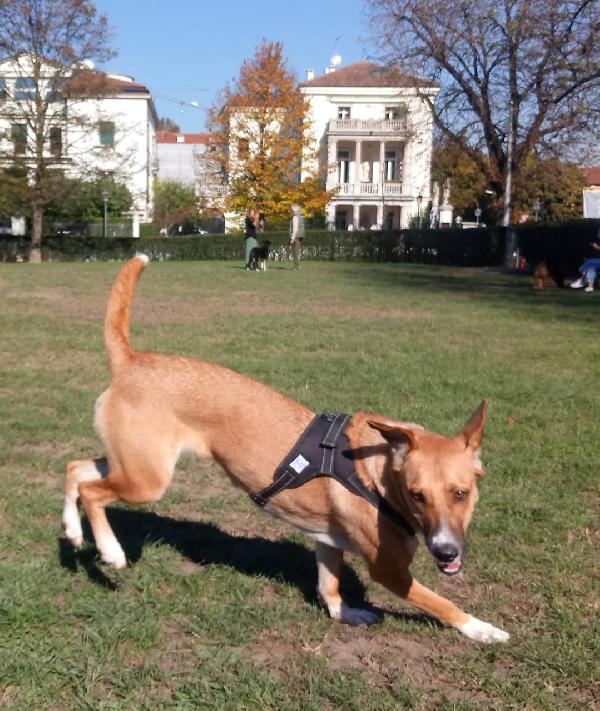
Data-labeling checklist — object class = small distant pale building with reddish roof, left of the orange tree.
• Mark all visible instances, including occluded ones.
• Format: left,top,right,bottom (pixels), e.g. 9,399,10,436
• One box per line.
156,131,208,186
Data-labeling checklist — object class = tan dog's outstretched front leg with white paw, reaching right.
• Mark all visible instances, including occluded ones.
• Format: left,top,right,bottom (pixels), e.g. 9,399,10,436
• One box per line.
371,566,509,642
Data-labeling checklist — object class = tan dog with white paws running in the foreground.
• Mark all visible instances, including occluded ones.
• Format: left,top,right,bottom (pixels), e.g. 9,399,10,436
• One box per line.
63,256,508,642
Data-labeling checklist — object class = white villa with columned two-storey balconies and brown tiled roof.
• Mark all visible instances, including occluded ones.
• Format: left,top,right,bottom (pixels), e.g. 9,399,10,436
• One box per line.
301,62,439,229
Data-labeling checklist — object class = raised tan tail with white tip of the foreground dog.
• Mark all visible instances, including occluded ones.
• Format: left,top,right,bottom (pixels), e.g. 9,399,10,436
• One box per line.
104,254,149,373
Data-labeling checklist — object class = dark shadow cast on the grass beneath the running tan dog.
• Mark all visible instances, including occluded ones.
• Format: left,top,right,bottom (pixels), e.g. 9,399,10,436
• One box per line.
58,508,437,624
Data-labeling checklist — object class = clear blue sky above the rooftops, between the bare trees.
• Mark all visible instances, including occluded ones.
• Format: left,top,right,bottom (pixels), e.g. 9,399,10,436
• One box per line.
96,0,373,132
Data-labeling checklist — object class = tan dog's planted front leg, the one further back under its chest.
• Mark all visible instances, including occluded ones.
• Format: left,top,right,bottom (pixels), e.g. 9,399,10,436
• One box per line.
315,541,379,625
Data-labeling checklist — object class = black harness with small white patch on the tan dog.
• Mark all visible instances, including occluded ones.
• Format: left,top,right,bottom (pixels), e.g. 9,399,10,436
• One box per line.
250,412,415,536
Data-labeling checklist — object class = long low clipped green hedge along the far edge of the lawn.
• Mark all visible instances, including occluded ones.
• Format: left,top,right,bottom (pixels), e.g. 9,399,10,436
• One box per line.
0,229,504,266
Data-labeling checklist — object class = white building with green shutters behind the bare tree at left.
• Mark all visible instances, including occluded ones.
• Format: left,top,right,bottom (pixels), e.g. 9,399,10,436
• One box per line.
0,55,157,222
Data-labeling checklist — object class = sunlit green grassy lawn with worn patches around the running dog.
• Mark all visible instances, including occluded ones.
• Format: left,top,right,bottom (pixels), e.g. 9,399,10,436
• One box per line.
0,262,600,711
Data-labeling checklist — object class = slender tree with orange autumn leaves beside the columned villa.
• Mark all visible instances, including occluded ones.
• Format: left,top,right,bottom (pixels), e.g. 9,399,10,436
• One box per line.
205,40,330,218
